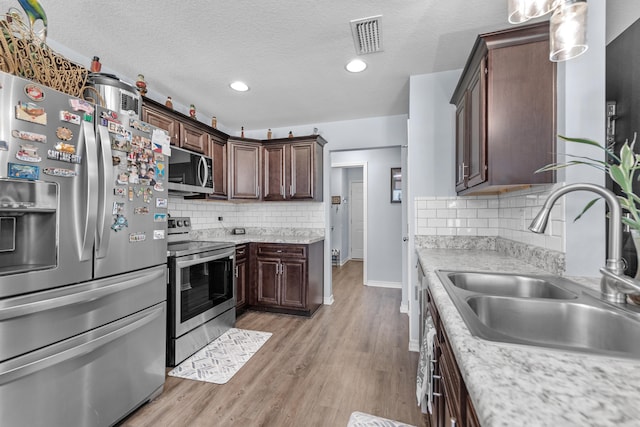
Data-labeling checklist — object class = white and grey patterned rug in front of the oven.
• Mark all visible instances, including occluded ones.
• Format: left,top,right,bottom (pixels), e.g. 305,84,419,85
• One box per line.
169,328,272,384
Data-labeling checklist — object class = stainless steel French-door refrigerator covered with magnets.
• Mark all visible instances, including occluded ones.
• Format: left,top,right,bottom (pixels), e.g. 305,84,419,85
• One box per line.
0,73,168,426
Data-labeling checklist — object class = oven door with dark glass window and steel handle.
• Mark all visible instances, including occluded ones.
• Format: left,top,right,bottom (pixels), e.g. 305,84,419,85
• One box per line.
172,254,235,336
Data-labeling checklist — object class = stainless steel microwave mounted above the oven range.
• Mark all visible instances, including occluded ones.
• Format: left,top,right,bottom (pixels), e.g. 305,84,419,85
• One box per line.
168,147,213,195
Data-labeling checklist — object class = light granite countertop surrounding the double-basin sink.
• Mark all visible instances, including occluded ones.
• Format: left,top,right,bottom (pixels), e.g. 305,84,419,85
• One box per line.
417,248,640,427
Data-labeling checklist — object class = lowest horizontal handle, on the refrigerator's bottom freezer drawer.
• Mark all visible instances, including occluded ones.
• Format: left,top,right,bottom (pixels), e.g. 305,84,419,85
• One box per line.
0,305,164,386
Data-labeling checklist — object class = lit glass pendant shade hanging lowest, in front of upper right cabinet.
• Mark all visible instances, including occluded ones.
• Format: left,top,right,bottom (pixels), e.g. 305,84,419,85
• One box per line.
549,0,588,62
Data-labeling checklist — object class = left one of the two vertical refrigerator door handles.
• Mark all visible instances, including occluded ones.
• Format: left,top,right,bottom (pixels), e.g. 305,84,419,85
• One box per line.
76,121,98,261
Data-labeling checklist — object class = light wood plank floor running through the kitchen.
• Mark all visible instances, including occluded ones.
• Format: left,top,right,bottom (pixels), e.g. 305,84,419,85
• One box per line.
122,261,424,427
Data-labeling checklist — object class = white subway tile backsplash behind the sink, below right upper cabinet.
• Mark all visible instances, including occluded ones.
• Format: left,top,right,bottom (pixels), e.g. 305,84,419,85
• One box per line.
415,185,565,252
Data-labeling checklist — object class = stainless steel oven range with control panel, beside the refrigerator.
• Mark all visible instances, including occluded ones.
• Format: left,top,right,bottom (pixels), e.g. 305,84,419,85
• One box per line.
167,217,236,366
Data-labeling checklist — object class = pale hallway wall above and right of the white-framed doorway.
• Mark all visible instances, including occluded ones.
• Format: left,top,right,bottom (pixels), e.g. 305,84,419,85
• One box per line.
331,146,402,287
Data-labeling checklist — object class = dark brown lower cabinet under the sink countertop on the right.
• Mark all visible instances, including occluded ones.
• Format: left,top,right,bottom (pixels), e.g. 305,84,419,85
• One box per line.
427,291,480,427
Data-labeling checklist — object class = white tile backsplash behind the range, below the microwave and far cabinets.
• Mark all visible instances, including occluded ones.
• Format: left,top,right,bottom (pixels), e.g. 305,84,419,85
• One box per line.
169,197,325,230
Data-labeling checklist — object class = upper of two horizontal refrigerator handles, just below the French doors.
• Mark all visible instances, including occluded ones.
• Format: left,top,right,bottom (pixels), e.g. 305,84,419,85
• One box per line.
0,270,165,321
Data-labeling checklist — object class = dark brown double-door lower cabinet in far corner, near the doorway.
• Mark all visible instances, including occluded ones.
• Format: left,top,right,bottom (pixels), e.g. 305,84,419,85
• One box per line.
249,241,324,316
